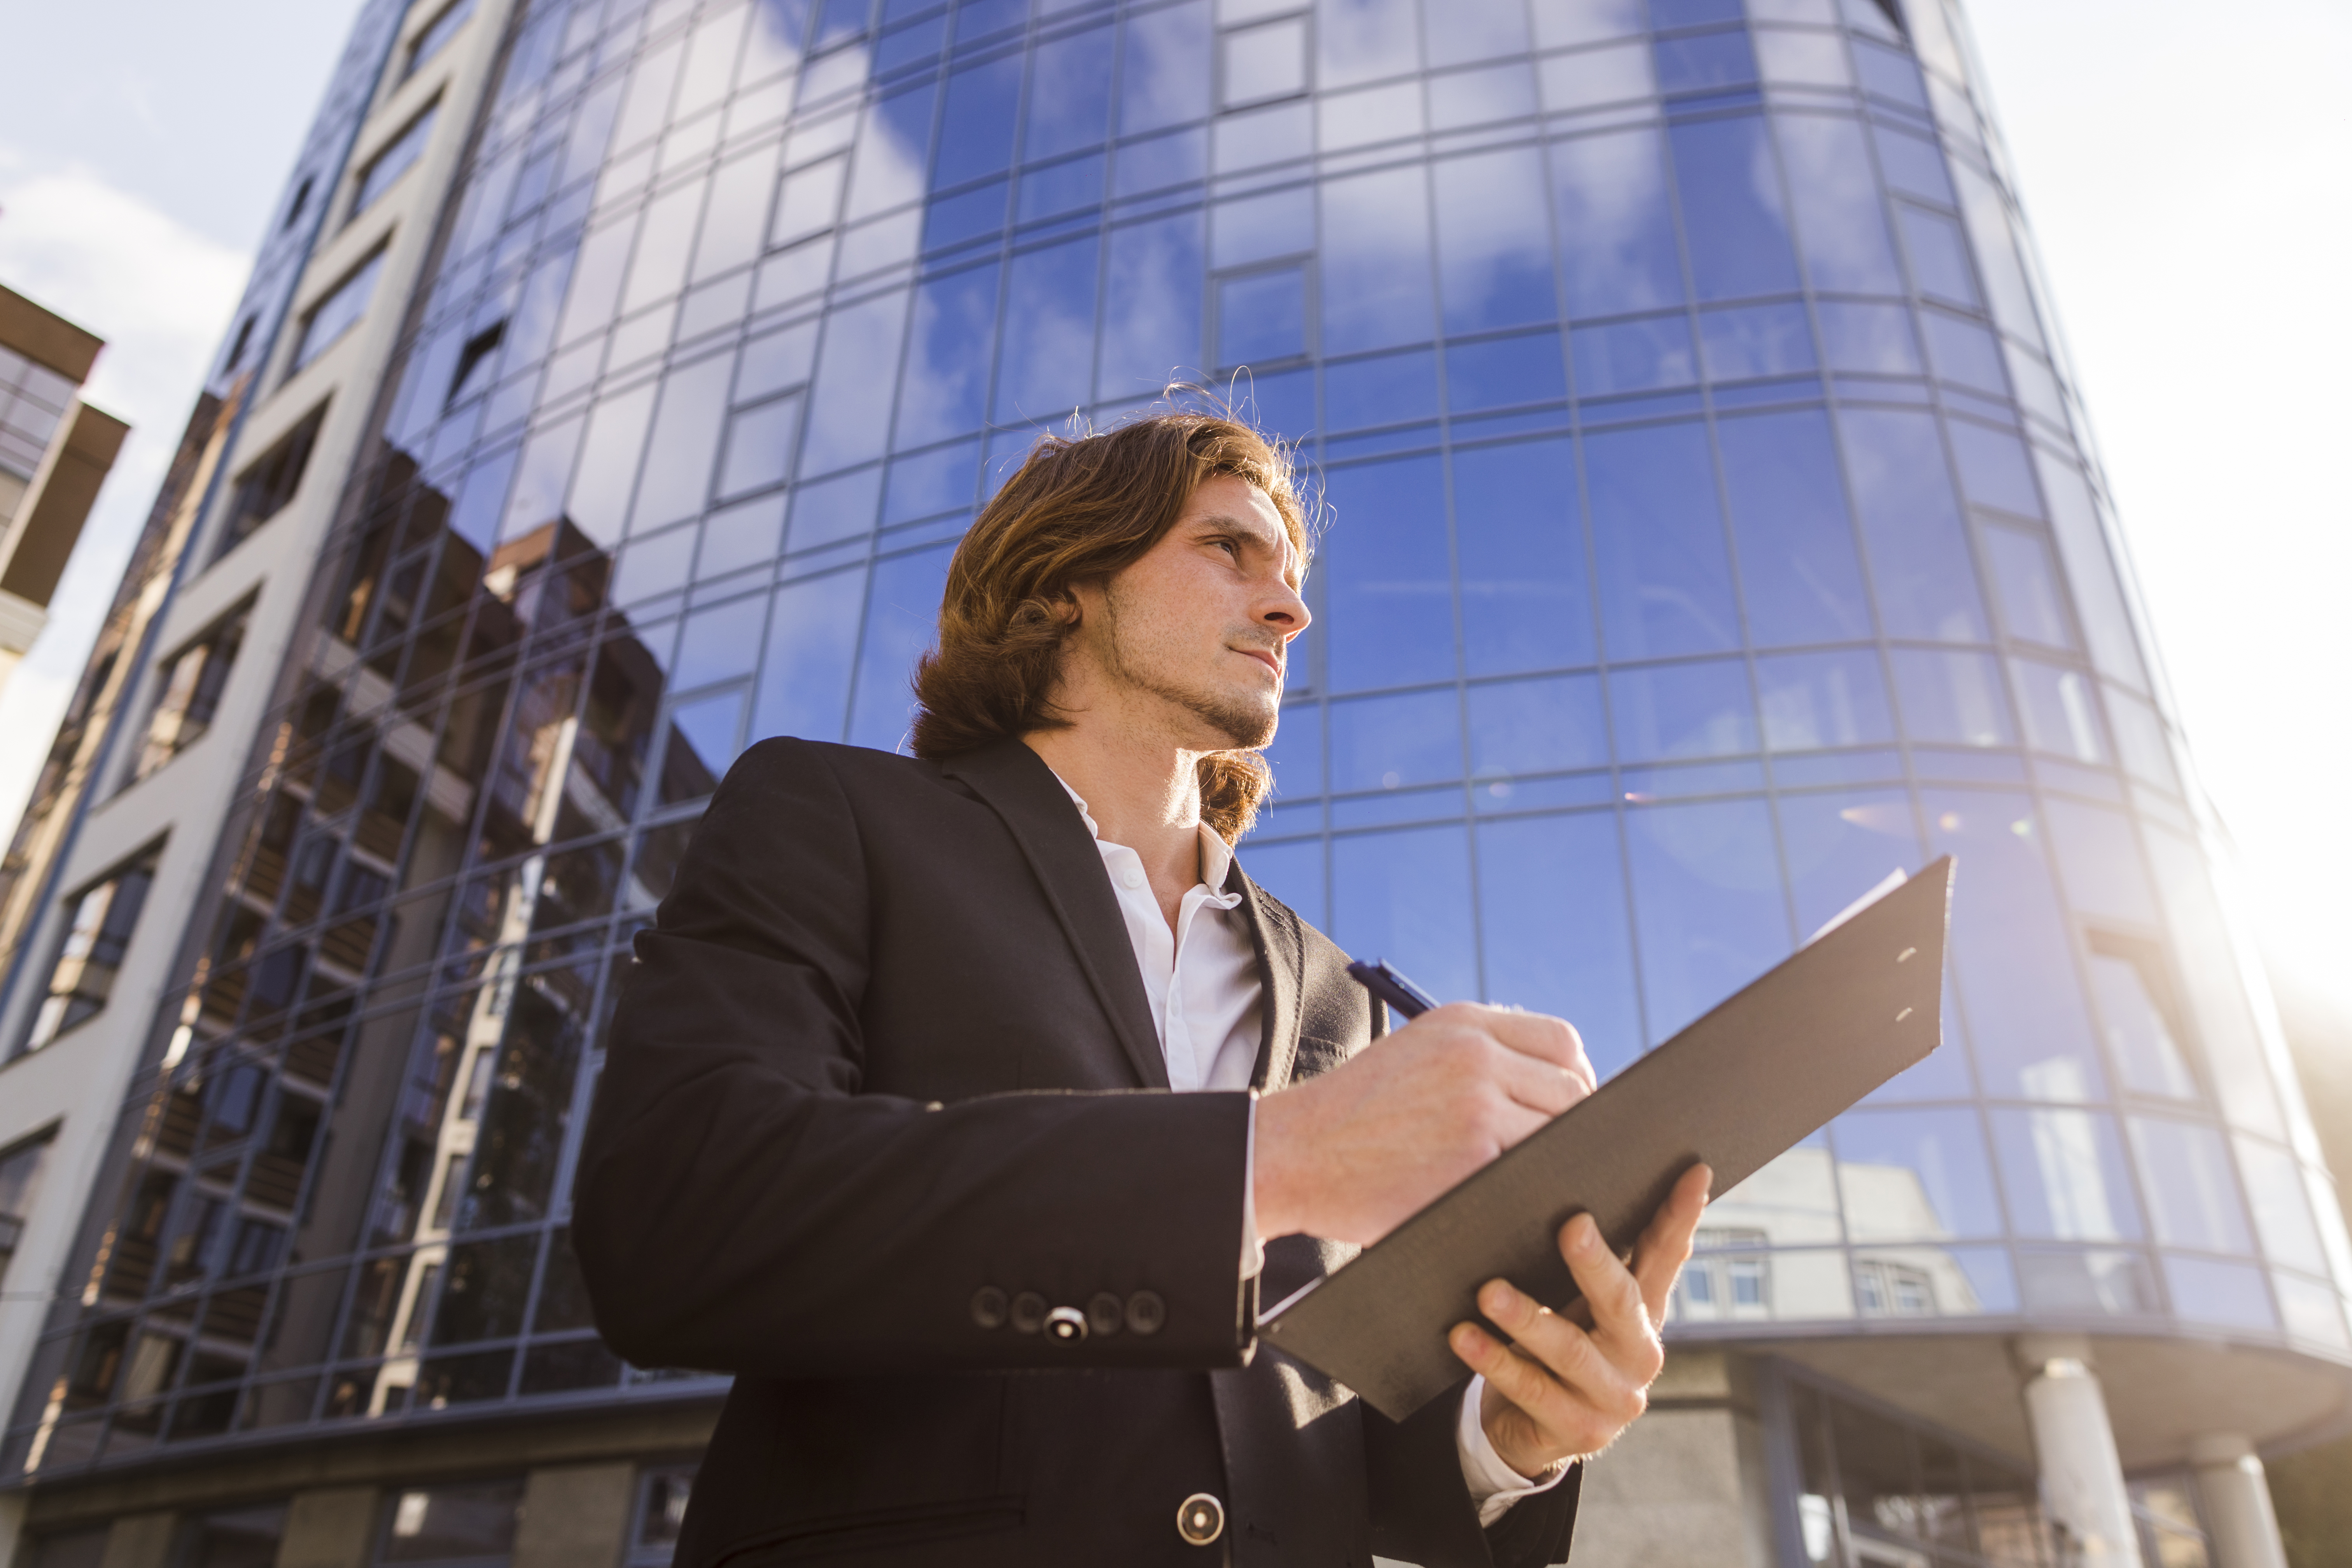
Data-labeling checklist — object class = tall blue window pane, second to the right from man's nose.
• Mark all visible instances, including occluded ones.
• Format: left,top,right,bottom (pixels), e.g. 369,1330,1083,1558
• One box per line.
1454,439,1595,675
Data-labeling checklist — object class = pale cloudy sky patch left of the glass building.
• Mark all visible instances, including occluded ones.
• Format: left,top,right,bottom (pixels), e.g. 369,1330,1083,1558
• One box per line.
0,0,357,851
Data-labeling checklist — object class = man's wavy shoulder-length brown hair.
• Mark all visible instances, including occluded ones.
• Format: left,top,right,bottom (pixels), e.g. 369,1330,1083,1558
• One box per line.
913,411,1312,844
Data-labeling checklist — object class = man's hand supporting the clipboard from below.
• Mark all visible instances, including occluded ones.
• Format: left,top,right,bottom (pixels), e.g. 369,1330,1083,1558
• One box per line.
1449,1166,1712,1476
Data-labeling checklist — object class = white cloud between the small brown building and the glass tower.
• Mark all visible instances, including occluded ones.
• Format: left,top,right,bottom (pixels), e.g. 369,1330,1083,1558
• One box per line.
0,160,252,835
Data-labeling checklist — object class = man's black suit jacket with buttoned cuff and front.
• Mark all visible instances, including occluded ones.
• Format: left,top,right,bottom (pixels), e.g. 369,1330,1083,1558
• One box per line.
574,740,1576,1568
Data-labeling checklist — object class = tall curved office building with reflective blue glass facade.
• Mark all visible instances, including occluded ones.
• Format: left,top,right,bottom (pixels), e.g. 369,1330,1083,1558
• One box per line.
0,0,2352,1568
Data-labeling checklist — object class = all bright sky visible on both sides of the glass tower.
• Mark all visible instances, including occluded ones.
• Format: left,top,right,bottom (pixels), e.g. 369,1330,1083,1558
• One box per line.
0,0,2352,1015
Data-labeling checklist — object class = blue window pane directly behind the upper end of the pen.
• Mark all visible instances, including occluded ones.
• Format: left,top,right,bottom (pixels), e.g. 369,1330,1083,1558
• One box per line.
1331,828,1479,1001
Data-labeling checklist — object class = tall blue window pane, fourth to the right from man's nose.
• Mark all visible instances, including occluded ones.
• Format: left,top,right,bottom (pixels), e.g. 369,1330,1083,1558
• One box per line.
1715,414,1872,646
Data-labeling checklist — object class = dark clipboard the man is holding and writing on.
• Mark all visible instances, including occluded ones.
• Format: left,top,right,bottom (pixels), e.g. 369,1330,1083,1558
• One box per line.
1258,856,1952,1420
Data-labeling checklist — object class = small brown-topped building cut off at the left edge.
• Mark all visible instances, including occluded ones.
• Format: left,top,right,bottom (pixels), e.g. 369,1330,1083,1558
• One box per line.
0,287,130,686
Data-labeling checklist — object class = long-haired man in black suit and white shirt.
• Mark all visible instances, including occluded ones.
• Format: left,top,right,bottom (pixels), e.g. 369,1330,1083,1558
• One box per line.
574,414,1708,1568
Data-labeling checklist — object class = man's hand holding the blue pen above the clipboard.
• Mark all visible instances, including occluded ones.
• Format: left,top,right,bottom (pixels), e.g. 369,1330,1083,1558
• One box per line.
1254,1001,1595,1246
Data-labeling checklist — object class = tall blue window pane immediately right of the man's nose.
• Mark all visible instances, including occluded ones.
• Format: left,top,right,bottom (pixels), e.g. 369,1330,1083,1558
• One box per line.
1322,458,1454,691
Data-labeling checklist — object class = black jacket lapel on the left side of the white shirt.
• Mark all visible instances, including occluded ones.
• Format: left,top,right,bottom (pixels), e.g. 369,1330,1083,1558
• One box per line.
941,740,1169,1088
